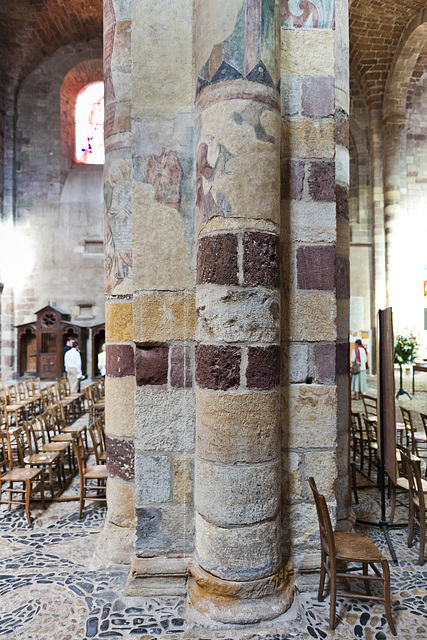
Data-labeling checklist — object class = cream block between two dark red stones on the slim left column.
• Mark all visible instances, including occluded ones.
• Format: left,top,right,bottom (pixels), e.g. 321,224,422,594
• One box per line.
105,376,136,438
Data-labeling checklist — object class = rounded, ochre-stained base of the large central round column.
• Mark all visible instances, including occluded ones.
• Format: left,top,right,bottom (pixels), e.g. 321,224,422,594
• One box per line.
188,560,294,624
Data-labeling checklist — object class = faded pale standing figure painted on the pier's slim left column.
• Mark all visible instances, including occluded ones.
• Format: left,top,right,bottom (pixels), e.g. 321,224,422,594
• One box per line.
104,159,132,293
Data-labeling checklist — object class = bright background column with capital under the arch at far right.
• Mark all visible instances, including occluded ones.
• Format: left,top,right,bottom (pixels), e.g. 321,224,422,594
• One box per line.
383,116,407,316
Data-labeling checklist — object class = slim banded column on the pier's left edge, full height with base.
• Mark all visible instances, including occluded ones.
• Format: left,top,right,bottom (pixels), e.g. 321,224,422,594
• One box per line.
93,0,135,568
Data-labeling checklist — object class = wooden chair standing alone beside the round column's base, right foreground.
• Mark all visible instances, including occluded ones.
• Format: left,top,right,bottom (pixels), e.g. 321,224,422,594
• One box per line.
308,478,396,635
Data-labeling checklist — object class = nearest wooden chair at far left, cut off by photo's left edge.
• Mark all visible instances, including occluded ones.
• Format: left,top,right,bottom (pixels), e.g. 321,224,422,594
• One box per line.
0,424,46,525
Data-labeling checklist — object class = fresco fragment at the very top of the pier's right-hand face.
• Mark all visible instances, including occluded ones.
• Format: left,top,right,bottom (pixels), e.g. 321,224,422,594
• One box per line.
281,0,334,29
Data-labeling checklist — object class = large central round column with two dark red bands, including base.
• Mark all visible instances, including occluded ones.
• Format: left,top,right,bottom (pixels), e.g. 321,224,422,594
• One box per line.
189,0,292,623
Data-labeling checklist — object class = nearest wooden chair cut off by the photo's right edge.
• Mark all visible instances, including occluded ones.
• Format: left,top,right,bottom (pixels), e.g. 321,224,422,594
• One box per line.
401,451,427,565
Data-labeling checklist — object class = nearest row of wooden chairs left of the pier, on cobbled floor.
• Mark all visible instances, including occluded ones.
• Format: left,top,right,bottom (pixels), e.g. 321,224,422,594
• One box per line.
0,403,107,524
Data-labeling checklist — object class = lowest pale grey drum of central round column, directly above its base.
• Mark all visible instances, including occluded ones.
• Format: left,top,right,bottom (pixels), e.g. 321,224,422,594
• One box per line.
195,514,280,580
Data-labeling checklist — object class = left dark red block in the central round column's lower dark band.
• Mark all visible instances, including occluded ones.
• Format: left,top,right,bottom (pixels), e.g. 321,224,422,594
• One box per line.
196,345,241,391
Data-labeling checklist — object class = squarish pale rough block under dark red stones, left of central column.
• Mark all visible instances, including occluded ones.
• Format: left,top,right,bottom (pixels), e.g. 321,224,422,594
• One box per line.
135,389,196,452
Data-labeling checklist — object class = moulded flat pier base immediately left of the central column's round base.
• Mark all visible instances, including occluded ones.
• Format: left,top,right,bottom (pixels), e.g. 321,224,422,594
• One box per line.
125,556,188,597
